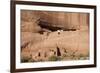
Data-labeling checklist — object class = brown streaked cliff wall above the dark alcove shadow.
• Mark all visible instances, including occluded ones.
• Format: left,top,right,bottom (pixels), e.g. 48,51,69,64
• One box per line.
21,10,89,30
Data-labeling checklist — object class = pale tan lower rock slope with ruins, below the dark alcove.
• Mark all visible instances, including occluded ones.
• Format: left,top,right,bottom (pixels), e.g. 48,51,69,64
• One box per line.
22,31,89,62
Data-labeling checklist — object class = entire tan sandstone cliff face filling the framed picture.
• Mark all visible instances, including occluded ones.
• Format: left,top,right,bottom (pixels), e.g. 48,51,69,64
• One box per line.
21,10,89,62
